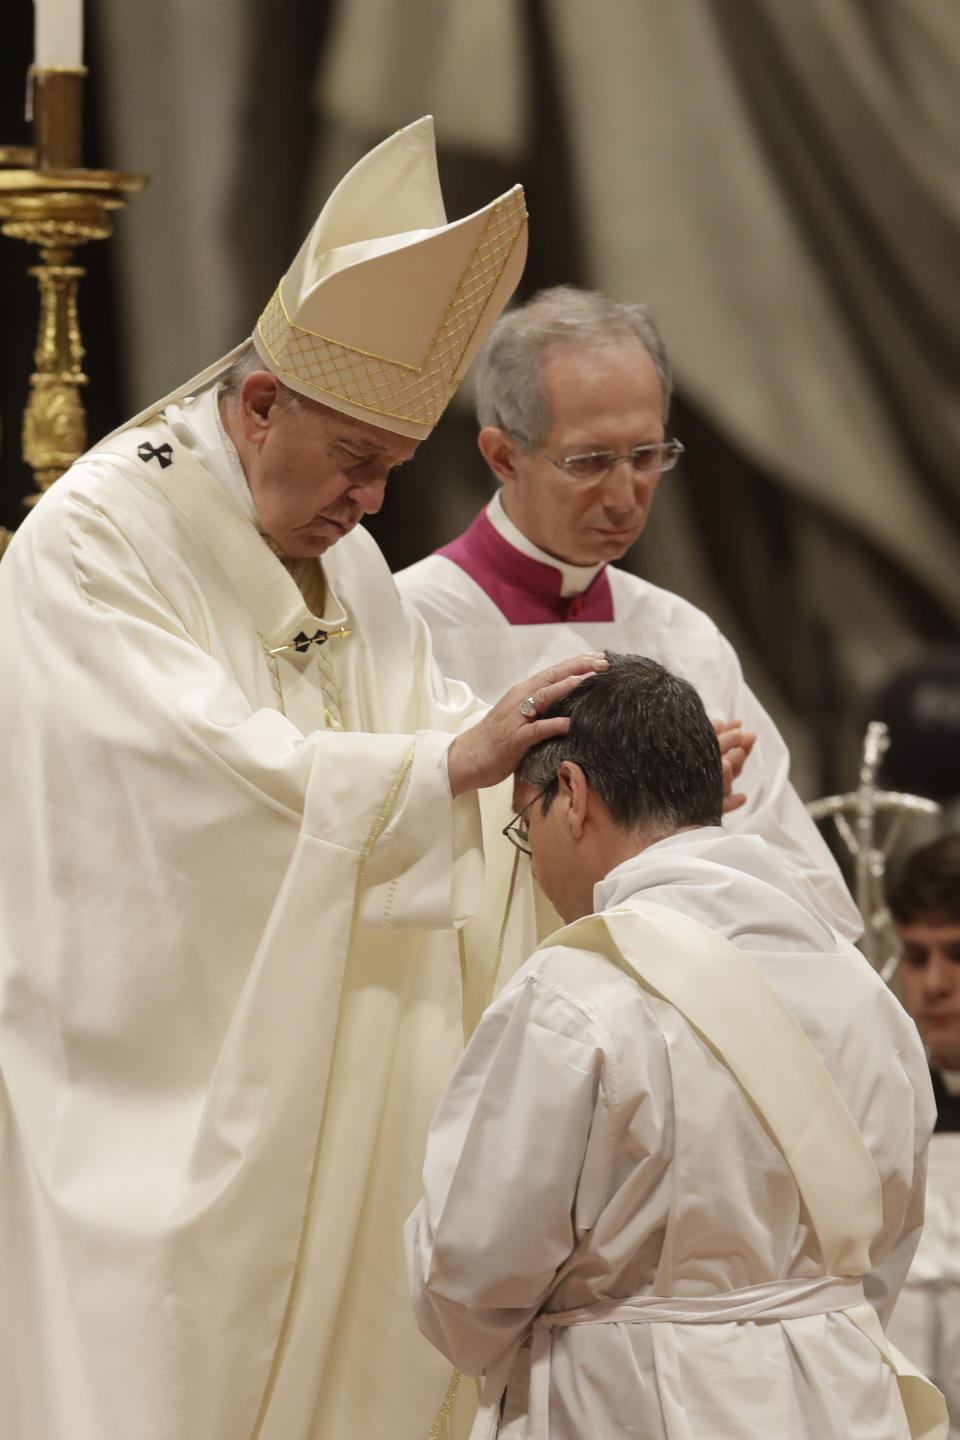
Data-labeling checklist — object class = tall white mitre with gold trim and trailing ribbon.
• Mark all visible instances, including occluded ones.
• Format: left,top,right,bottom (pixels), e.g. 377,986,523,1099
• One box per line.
122,115,527,439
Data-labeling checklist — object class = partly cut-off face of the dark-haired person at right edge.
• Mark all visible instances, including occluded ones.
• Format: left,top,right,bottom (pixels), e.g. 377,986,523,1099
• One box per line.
897,916,960,1070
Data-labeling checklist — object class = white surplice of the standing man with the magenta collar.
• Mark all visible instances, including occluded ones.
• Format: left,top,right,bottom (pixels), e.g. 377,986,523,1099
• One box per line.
394,494,864,939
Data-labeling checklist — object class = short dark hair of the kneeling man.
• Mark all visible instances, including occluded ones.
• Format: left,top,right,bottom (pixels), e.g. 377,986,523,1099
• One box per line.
517,651,724,832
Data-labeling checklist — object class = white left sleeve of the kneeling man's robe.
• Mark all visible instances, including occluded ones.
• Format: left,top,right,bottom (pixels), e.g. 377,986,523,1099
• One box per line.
406,976,610,1375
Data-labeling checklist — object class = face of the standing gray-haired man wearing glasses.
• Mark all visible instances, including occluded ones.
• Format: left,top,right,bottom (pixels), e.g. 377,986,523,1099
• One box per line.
502,340,664,564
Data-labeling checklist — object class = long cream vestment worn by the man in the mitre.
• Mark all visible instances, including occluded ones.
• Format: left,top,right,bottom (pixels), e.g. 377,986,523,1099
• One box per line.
0,396,518,1440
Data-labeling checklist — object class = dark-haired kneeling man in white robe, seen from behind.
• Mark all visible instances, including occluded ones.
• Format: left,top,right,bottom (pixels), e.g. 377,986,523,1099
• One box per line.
407,655,946,1440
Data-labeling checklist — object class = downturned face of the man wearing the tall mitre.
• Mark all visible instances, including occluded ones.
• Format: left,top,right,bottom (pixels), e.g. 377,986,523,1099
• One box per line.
245,383,417,556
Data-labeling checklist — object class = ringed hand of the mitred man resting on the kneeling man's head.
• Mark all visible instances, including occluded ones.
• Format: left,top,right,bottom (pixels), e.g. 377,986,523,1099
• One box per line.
446,652,609,795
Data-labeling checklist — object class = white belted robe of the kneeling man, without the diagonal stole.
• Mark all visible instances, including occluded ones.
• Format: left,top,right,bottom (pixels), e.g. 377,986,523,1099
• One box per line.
407,827,934,1440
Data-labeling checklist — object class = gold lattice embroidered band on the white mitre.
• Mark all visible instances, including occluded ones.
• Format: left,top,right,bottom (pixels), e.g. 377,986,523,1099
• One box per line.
256,190,527,425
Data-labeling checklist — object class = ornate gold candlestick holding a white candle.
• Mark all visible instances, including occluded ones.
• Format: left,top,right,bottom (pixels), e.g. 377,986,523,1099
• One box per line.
0,66,147,518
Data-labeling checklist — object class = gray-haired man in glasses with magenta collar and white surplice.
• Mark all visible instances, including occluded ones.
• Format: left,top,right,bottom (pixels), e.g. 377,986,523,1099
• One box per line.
396,287,862,937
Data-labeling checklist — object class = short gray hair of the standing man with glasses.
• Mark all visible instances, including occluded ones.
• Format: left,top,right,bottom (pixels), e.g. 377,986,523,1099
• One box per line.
474,285,672,451
